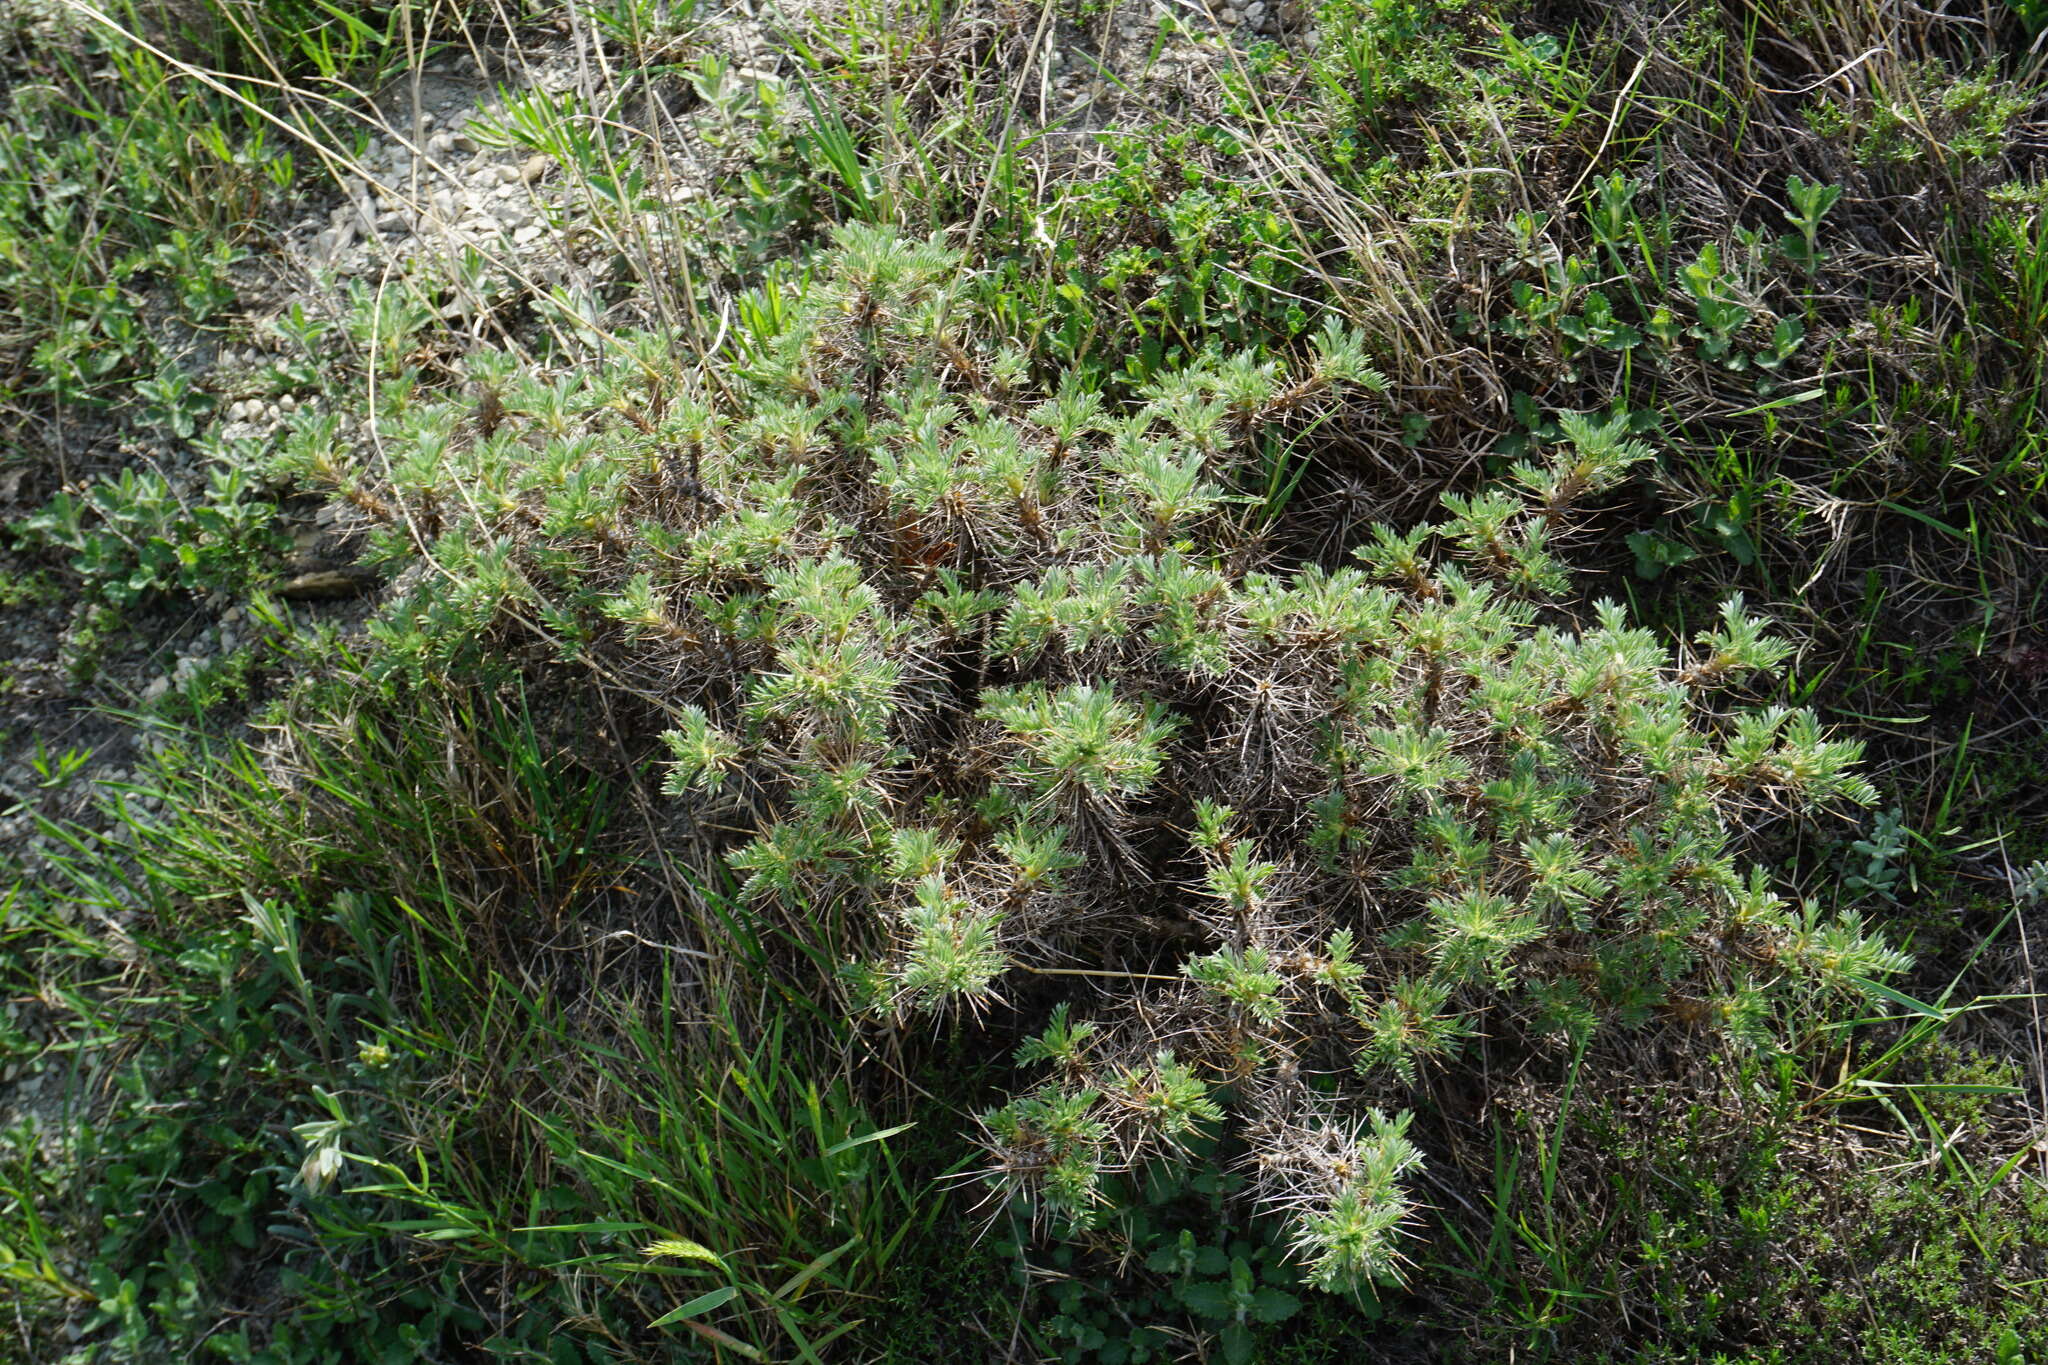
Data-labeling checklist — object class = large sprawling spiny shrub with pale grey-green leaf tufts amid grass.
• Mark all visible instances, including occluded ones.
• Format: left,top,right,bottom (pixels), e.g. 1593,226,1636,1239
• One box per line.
307,227,1905,1289
